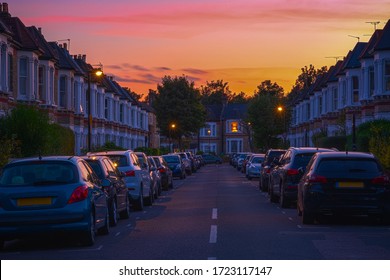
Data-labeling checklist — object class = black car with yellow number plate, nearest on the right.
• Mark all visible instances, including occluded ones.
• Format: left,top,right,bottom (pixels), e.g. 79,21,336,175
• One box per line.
297,152,390,224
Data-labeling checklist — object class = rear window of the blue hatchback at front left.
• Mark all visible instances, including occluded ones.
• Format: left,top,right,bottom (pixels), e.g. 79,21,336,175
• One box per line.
0,161,77,186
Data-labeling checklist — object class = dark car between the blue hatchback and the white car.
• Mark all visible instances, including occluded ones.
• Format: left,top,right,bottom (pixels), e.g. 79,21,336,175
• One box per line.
82,156,130,226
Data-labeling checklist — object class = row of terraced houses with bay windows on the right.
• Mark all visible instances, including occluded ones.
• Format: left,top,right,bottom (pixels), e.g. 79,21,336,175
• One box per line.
288,20,390,146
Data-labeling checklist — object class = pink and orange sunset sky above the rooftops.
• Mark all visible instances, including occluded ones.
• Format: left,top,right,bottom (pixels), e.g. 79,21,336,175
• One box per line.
7,0,390,95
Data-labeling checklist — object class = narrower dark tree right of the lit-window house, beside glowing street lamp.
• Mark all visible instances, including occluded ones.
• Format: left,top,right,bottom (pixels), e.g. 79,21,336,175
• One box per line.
248,80,287,151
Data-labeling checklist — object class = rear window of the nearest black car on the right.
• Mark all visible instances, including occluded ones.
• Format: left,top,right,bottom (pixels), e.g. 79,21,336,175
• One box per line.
315,158,381,178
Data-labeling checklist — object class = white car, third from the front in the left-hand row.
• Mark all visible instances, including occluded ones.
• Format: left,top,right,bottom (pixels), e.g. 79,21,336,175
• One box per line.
88,150,153,211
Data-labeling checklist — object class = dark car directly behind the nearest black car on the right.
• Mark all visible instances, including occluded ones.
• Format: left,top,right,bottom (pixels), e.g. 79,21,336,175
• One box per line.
269,147,333,208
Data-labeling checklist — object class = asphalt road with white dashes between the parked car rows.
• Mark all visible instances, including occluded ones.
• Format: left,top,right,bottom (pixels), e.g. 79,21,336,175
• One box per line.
0,164,390,260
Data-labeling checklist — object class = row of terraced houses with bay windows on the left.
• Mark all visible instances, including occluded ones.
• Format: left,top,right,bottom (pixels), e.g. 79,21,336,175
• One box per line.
0,3,158,154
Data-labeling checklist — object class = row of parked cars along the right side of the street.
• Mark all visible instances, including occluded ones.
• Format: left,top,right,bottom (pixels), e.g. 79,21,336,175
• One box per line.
231,147,390,224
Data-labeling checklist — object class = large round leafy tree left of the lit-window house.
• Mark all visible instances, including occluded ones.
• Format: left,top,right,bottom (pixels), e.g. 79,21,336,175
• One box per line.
153,76,206,148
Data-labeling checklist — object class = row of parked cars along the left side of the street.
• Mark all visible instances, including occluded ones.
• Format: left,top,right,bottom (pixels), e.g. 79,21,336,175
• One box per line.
0,150,215,248
